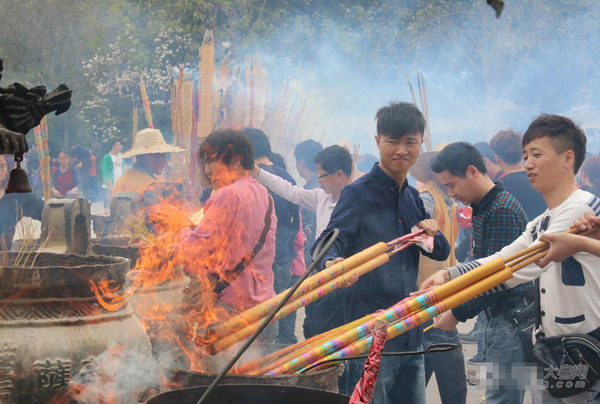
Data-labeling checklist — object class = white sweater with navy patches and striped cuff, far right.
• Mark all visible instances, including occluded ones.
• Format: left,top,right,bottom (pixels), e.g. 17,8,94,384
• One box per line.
448,190,600,337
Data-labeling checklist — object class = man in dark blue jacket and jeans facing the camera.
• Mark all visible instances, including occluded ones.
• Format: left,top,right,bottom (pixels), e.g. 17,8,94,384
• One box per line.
314,103,450,404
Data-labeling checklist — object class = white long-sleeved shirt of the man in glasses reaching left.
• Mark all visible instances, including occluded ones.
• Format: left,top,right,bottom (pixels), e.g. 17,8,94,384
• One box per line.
256,170,337,239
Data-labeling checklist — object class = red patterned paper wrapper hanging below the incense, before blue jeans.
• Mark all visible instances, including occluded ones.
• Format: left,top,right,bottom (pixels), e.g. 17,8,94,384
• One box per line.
349,320,388,404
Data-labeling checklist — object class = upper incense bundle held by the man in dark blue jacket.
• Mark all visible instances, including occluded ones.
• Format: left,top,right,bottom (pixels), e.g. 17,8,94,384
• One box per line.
202,230,424,354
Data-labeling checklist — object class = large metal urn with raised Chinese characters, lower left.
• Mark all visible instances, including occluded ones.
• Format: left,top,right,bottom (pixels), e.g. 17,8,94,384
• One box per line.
0,253,150,404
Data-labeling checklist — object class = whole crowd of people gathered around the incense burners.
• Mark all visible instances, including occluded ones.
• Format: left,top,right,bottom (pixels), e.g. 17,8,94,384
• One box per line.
0,102,600,404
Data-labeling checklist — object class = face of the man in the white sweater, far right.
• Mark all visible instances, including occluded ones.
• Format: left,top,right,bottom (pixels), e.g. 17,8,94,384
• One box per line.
523,136,573,193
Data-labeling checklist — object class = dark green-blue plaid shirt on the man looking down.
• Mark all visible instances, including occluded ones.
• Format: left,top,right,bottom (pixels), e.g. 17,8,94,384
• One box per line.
452,183,534,321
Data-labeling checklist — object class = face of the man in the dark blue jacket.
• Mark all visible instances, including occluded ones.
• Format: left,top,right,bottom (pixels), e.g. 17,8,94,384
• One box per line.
375,133,423,178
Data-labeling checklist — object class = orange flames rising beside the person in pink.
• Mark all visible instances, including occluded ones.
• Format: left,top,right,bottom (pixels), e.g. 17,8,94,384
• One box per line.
90,162,262,371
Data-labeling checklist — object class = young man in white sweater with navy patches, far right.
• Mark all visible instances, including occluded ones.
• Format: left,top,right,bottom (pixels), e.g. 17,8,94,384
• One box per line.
421,114,600,404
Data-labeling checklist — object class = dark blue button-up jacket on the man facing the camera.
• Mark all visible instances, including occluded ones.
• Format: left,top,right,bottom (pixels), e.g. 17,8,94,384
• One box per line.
321,163,450,350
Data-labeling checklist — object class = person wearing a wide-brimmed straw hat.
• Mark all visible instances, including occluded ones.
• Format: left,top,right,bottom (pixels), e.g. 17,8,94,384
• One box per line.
113,128,185,200
